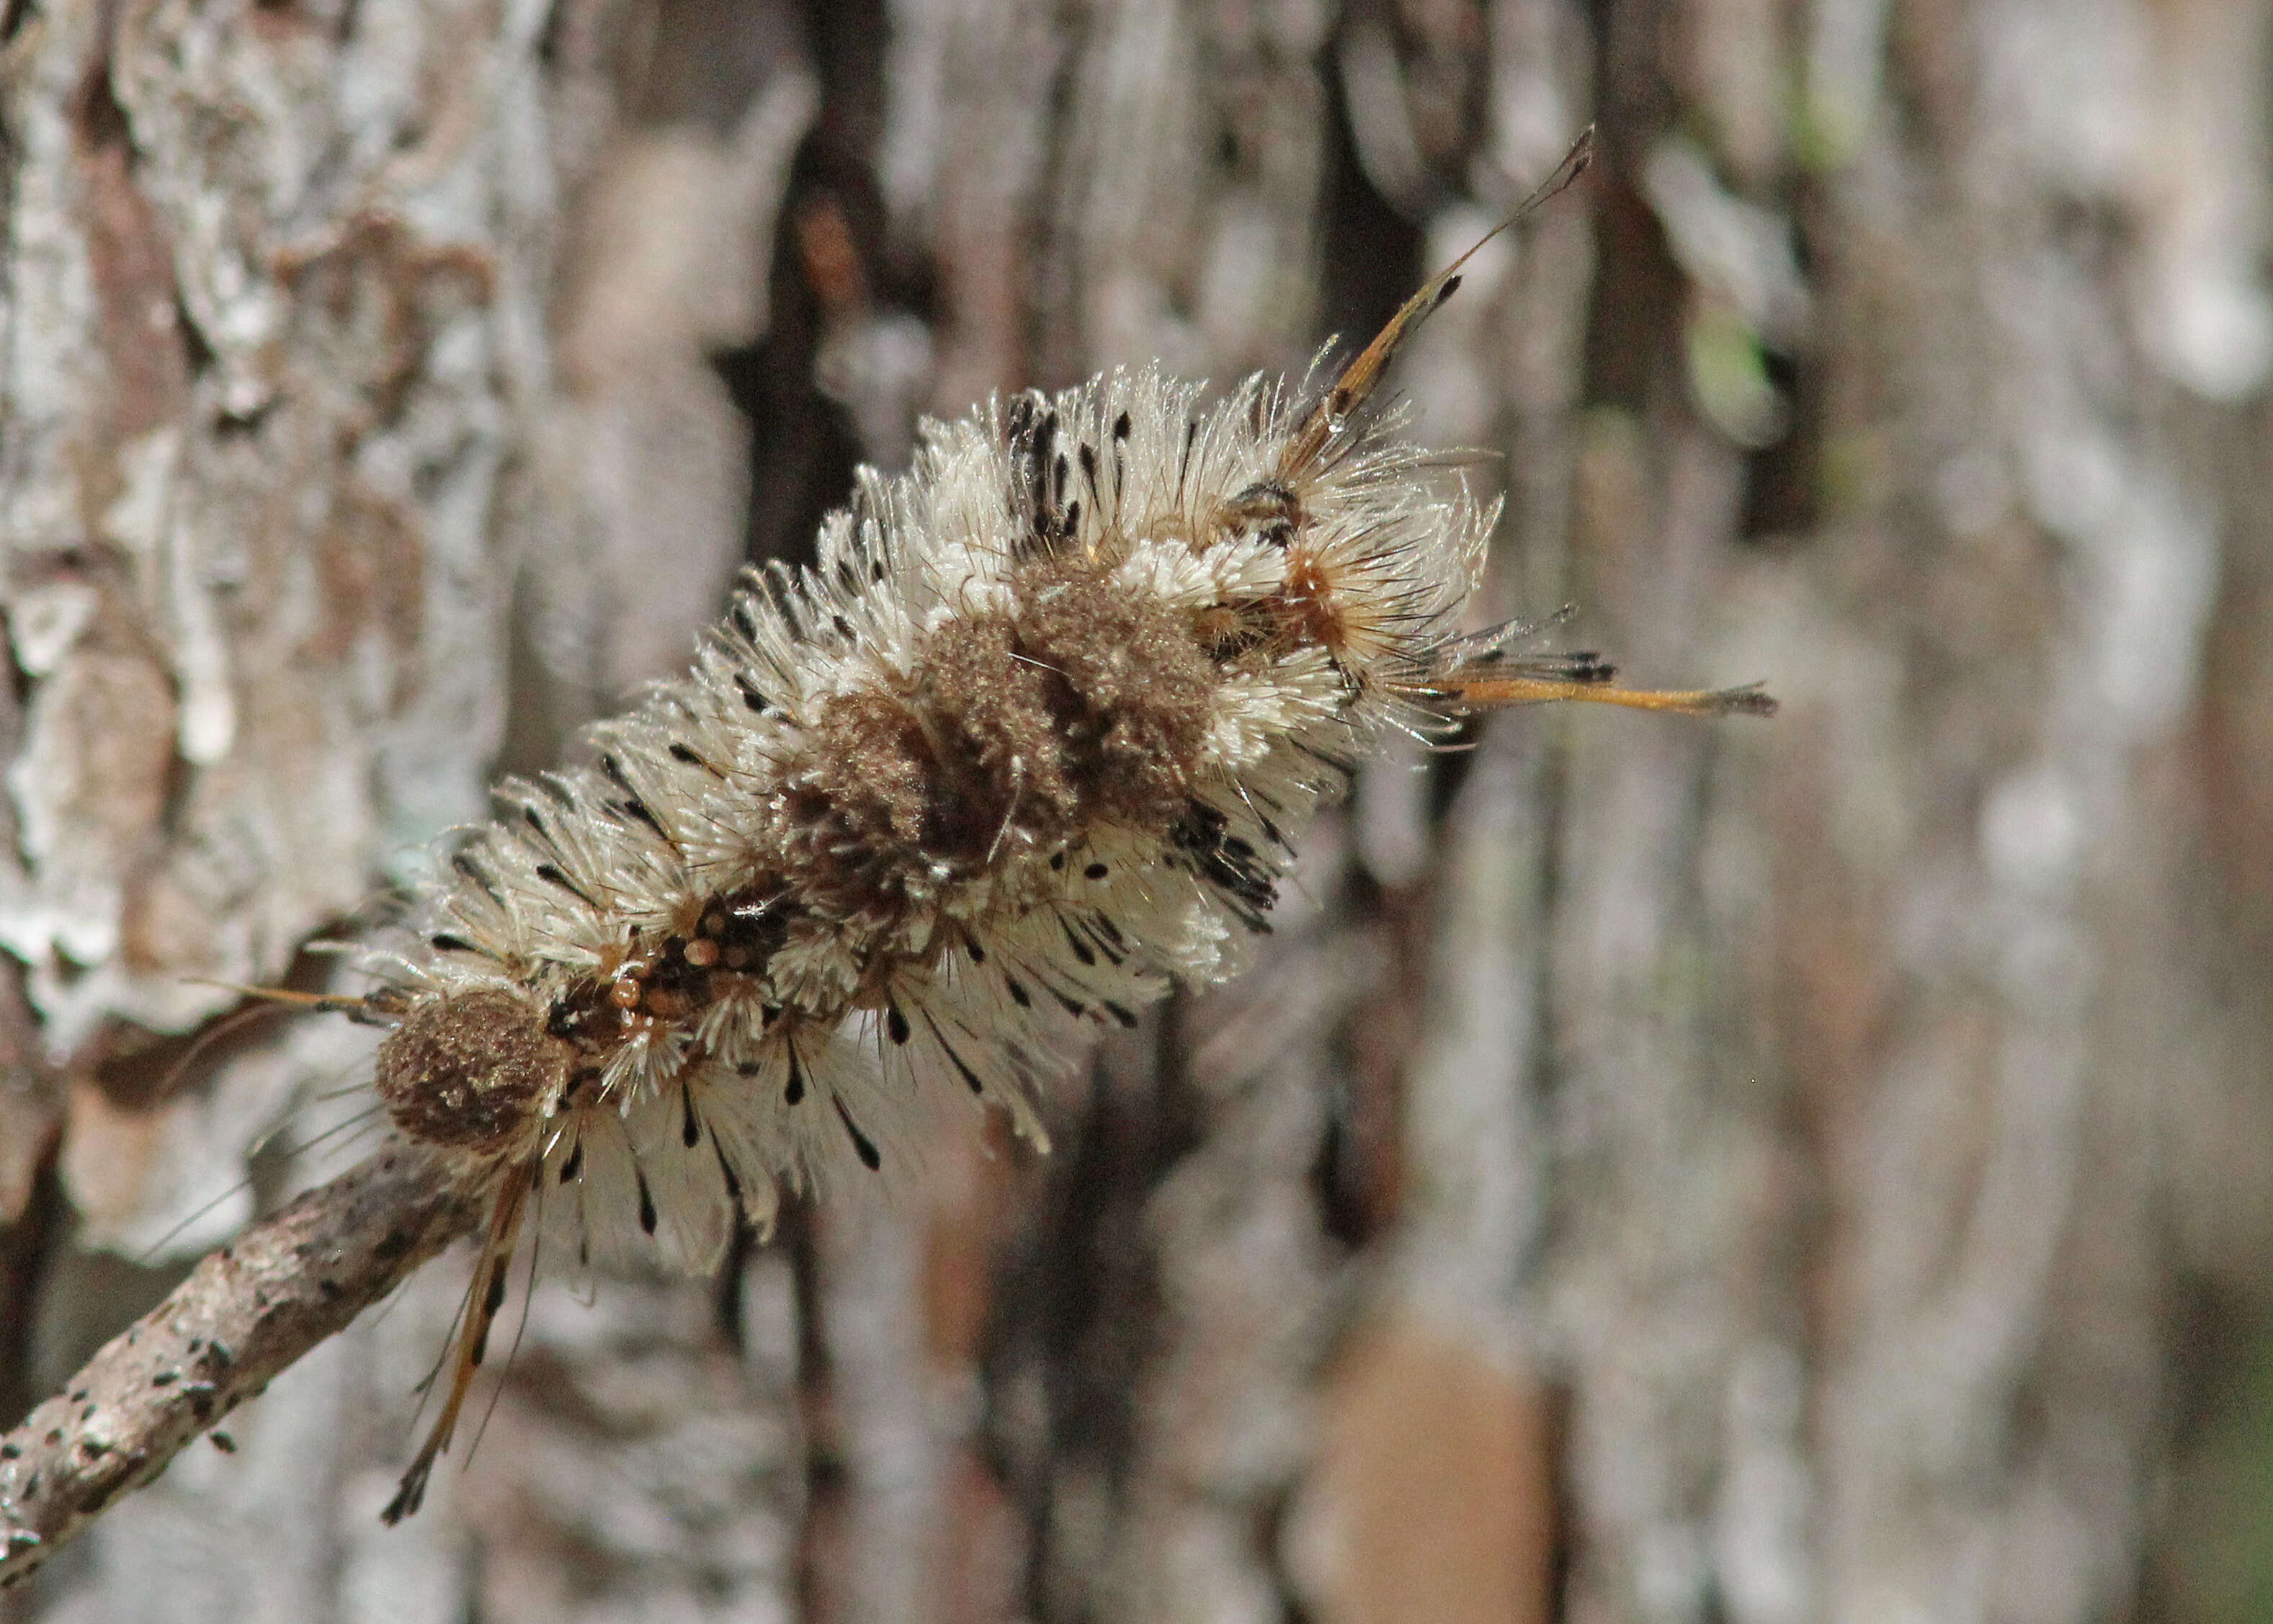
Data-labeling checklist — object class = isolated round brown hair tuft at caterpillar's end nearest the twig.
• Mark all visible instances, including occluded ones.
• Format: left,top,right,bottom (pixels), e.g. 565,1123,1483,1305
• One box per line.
378,987,571,1156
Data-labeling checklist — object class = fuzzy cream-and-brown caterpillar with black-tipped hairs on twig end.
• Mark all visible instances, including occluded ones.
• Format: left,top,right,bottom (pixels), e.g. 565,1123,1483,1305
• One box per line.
325,129,1773,1522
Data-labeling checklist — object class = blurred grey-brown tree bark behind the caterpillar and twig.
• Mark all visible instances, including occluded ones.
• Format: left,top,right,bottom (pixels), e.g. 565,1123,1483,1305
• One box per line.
0,0,2273,1624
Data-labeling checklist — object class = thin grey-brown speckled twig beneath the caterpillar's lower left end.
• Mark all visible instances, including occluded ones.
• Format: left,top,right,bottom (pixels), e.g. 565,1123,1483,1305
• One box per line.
0,1144,478,1587
